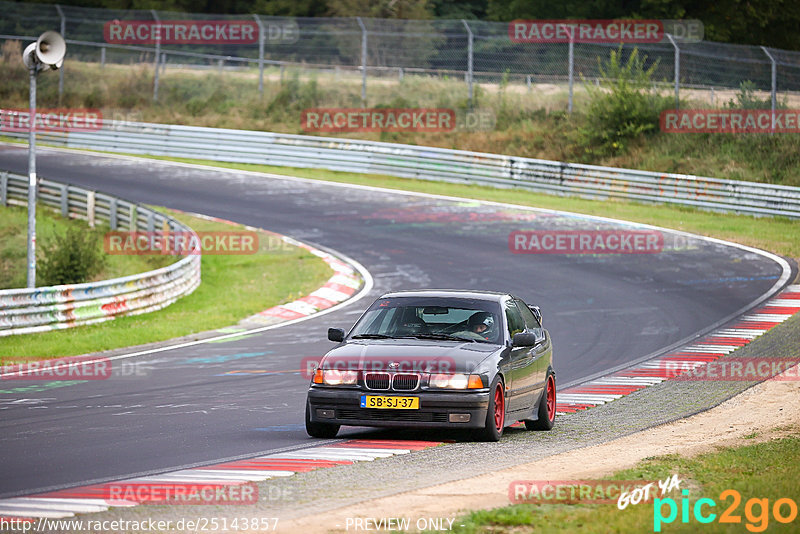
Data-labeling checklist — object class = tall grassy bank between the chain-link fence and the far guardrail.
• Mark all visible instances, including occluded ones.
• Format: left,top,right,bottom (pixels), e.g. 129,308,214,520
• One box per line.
0,55,800,186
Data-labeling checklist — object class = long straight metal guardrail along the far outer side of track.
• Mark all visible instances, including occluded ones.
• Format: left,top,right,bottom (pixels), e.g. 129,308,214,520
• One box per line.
5,121,800,218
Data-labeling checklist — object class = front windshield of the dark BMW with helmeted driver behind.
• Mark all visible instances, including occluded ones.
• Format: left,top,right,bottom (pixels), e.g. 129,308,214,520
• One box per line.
350,297,501,343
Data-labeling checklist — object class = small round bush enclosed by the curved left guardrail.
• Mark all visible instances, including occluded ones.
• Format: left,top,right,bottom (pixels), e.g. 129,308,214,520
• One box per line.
36,226,105,286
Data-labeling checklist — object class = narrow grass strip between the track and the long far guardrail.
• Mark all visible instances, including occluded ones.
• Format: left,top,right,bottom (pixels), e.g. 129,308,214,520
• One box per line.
144,156,800,259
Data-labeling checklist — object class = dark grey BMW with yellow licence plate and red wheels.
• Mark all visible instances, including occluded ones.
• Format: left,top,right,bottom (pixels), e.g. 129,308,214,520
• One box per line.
306,290,556,441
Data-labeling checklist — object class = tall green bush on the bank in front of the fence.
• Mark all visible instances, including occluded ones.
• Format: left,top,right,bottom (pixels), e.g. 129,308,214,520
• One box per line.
578,47,672,155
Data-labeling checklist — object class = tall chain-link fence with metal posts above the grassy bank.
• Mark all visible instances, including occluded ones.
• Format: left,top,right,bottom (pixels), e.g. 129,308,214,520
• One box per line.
0,1,800,109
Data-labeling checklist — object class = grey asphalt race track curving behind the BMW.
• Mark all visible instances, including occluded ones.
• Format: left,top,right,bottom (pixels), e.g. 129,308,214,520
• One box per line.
0,146,782,497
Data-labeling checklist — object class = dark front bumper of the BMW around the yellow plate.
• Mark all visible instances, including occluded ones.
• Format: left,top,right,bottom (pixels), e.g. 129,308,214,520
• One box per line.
308,387,489,428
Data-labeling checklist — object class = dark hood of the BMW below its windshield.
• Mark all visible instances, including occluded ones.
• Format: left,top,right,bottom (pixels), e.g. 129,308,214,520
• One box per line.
321,339,502,373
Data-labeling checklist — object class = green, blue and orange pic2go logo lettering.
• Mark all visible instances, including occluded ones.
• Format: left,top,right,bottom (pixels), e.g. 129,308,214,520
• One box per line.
653,489,797,532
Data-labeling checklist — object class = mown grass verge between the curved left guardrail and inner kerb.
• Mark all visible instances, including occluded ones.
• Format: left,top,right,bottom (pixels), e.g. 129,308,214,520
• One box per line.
0,210,333,364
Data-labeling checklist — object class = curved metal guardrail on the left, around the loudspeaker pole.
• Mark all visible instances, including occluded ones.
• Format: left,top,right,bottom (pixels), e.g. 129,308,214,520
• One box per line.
0,172,200,337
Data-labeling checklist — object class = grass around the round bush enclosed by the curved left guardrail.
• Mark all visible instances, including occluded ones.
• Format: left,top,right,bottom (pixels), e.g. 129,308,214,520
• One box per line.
0,205,175,289
